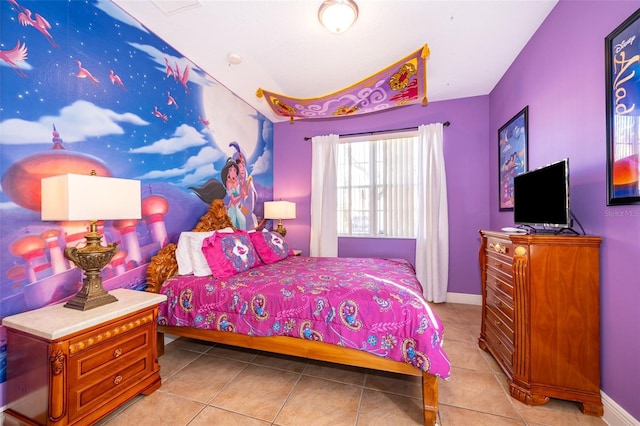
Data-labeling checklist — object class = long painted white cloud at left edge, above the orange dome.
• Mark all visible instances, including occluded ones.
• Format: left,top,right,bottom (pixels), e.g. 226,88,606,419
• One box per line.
0,100,149,145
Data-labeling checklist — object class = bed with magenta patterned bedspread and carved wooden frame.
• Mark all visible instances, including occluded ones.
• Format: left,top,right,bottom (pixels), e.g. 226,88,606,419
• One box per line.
147,200,450,425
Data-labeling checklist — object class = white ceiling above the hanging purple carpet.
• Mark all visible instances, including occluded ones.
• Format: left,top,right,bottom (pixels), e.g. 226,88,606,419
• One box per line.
113,0,558,122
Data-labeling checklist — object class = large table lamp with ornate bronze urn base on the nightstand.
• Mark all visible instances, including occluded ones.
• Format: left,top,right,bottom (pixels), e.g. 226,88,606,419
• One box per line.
41,171,142,311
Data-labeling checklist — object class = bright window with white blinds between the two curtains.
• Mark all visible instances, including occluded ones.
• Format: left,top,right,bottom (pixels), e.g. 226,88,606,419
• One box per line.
337,130,418,238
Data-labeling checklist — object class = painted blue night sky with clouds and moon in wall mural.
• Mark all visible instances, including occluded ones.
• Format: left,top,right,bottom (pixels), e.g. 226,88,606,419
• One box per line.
0,0,273,207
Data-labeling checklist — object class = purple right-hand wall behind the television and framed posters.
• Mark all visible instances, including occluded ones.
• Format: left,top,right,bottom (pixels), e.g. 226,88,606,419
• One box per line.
489,0,640,419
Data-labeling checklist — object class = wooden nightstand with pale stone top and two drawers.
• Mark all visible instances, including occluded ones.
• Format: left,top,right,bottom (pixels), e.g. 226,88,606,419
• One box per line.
2,289,166,425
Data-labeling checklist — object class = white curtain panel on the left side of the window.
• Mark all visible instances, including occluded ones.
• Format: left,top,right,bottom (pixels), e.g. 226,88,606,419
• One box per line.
309,135,340,257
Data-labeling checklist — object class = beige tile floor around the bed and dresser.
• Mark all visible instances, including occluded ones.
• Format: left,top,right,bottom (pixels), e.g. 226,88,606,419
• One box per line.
100,303,605,426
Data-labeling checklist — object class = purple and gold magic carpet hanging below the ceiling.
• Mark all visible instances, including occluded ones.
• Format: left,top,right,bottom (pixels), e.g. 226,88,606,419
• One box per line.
256,44,430,122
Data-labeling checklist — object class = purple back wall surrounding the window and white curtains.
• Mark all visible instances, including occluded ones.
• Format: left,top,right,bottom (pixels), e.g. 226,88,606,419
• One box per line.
273,96,490,294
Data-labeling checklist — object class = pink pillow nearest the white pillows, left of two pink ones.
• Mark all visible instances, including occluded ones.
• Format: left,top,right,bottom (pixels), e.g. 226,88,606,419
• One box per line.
202,231,260,278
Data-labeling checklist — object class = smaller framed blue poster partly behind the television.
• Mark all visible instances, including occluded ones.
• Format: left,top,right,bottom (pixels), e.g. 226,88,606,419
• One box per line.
498,106,529,211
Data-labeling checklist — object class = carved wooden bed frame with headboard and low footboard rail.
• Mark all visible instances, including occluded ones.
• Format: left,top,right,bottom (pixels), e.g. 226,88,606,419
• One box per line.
147,200,438,425
